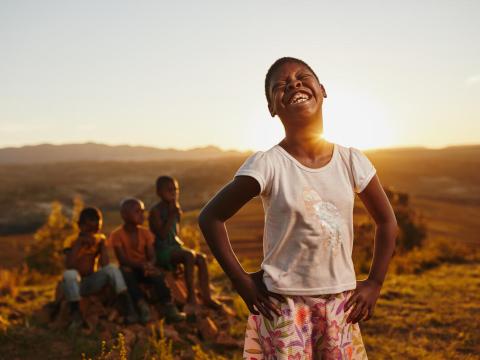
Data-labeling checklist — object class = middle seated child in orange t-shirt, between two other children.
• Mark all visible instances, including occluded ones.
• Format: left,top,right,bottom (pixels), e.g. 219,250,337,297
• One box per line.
109,198,185,323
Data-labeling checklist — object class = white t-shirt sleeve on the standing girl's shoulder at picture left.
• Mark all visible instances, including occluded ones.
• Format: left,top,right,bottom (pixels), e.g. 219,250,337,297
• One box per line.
234,151,272,194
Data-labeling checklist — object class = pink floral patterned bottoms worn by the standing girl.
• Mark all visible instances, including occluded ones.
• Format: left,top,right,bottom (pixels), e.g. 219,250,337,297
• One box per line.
243,290,367,360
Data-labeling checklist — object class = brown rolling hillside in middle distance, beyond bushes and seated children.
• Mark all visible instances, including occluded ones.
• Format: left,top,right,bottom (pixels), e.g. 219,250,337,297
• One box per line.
0,146,480,241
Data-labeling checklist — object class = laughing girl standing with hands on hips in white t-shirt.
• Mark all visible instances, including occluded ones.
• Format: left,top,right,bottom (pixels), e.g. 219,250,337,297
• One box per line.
199,58,398,360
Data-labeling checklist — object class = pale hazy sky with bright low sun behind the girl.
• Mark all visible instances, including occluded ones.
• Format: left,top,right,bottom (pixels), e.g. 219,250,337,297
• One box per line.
0,0,480,150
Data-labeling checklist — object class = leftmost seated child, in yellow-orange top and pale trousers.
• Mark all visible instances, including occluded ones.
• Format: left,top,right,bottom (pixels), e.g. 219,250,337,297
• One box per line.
63,207,136,329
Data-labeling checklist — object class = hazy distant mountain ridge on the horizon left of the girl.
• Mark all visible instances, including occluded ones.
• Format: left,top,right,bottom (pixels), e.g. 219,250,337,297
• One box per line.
0,143,247,164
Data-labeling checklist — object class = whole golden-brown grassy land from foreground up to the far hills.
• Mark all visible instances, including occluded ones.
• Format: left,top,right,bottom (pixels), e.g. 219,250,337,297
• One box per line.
0,143,480,360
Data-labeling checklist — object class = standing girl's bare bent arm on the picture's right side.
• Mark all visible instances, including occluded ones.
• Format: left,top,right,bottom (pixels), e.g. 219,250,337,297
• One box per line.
345,175,398,323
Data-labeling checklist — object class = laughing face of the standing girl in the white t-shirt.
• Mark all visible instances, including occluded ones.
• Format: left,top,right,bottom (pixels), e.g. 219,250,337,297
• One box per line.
268,62,327,122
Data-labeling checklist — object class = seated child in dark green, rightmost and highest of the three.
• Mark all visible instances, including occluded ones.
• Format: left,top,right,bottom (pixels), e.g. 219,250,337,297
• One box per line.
149,176,222,313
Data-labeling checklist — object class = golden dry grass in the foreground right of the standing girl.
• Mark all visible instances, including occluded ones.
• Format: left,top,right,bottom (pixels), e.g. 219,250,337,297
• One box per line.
361,263,480,359
